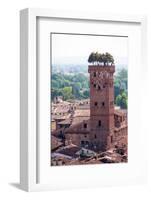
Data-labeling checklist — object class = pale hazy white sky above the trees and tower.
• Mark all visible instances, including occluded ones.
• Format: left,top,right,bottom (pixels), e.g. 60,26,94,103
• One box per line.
52,34,128,64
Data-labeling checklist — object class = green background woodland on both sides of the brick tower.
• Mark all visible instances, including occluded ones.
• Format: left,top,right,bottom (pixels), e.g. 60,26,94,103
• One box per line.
51,68,128,108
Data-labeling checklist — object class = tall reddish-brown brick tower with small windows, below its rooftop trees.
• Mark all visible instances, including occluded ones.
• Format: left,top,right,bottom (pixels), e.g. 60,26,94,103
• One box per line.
88,65,115,150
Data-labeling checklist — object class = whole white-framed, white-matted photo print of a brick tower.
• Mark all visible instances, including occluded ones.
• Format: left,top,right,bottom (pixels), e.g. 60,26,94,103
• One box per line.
20,9,147,191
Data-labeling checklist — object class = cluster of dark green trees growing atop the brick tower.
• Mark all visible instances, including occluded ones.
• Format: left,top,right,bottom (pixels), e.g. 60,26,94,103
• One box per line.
88,52,114,66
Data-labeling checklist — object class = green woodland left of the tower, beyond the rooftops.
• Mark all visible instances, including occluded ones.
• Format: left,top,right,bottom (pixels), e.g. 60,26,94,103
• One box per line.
51,73,89,100
